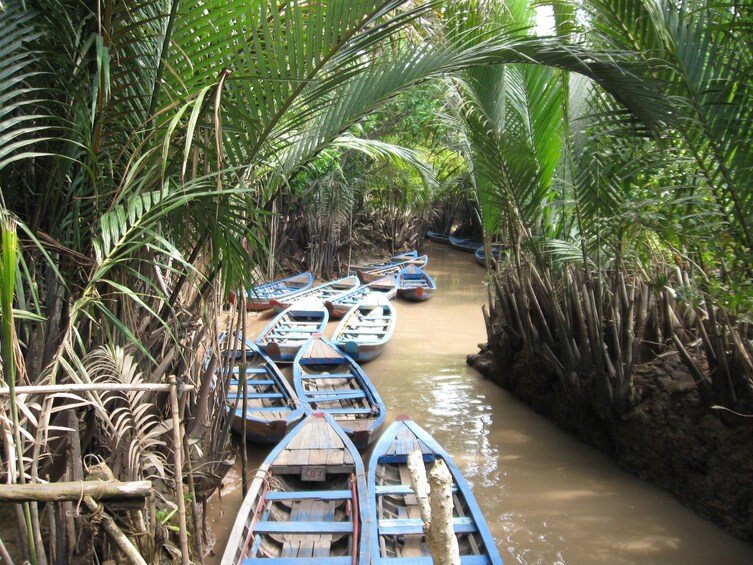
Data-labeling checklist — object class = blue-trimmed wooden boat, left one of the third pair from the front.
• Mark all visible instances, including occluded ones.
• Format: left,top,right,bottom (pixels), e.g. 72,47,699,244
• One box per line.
255,299,329,363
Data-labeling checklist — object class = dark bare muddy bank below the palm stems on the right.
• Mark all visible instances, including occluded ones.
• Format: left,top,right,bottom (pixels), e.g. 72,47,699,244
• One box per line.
468,345,753,542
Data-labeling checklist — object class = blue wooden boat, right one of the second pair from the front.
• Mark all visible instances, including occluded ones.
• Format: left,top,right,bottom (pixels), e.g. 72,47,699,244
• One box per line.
293,336,387,449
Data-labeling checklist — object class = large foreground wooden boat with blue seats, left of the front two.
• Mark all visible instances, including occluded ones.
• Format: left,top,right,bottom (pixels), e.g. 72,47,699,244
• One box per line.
222,413,371,565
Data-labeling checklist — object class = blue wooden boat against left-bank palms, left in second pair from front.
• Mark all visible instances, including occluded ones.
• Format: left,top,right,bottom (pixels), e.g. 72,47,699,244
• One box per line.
220,340,304,443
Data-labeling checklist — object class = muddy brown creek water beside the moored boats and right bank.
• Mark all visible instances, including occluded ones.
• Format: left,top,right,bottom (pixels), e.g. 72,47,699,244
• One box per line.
204,243,753,565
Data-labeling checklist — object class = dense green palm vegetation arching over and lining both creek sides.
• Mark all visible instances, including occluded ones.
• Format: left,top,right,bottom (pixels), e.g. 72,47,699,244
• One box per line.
0,0,753,562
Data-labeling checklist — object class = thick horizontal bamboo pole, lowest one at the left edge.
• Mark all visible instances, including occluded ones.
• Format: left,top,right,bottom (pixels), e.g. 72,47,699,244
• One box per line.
0,481,152,502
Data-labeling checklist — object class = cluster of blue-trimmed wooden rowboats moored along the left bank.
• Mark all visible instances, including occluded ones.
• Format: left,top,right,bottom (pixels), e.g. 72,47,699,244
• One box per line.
216,252,502,565
